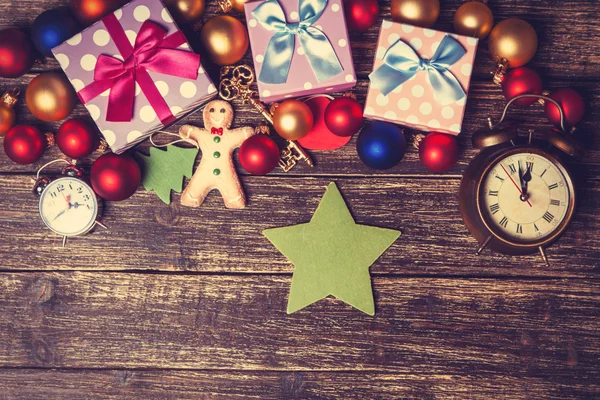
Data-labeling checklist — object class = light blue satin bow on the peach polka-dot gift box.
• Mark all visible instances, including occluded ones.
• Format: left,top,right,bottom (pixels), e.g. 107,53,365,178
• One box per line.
369,35,467,106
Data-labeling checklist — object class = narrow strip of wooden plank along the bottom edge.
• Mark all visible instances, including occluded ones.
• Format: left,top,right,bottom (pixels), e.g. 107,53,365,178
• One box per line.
0,369,600,400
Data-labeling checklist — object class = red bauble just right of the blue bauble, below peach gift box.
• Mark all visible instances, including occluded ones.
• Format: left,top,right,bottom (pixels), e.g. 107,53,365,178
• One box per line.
419,132,458,172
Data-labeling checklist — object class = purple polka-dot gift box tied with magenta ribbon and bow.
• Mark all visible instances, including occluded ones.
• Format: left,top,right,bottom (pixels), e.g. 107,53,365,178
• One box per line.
52,0,217,153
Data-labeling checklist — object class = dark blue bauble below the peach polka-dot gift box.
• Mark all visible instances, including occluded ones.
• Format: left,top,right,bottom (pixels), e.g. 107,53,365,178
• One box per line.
356,122,406,169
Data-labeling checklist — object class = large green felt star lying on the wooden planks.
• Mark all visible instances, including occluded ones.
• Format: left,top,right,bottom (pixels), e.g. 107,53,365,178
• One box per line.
263,182,400,315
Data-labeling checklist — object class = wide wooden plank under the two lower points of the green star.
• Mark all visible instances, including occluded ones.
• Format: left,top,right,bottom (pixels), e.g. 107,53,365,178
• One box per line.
0,272,600,376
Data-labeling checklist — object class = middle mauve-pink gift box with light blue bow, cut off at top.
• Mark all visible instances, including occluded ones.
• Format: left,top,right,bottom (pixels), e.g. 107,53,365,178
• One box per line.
244,0,356,103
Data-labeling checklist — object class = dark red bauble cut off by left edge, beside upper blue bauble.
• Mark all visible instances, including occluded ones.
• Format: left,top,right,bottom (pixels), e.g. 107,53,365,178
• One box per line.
0,28,35,78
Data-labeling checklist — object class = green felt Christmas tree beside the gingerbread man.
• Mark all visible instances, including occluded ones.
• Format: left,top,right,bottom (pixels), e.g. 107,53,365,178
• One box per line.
138,146,198,204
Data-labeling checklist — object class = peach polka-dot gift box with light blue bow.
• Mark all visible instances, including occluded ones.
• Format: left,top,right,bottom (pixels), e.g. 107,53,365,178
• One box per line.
364,20,477,135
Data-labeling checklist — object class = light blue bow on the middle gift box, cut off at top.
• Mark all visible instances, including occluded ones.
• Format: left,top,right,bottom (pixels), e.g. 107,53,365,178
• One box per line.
252,0,343,83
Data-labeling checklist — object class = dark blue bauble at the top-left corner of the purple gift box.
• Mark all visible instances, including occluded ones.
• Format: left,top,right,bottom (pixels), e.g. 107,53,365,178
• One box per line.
31,8,79,57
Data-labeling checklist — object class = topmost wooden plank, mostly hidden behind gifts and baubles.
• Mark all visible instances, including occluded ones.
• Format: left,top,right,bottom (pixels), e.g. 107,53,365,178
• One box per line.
0,0,600,80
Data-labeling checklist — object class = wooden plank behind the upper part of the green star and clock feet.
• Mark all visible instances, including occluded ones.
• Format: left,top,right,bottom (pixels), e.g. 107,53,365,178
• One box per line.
0,176,600,277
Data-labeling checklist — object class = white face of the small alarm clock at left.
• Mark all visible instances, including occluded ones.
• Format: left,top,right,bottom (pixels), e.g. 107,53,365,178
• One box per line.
40,177,98,236
